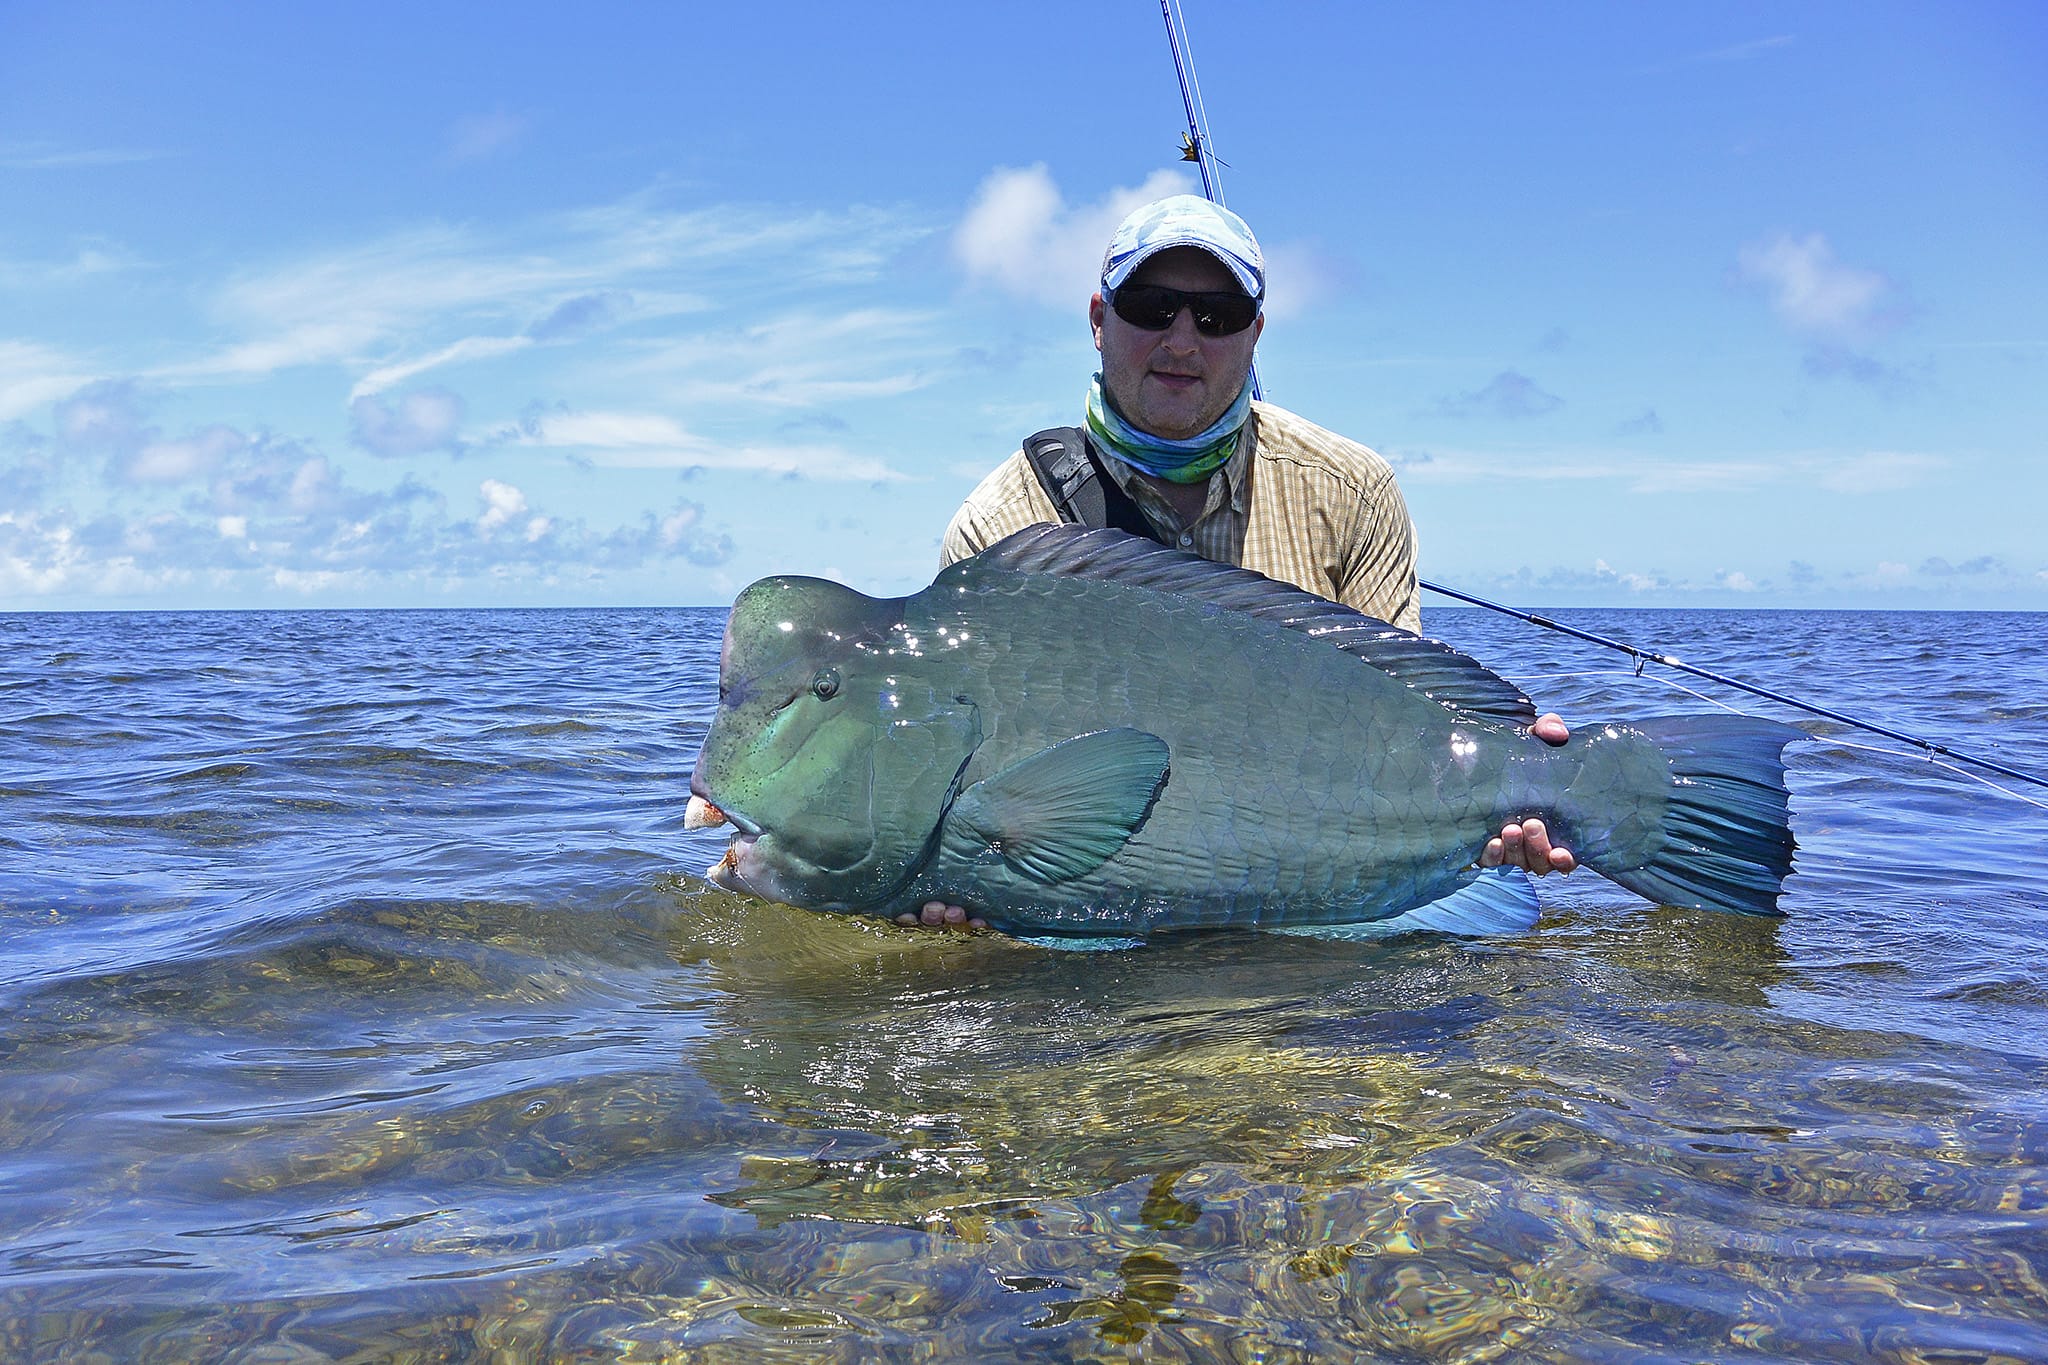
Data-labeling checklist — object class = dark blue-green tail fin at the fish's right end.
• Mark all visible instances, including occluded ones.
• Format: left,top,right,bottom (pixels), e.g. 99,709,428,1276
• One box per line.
1585,714,1806,915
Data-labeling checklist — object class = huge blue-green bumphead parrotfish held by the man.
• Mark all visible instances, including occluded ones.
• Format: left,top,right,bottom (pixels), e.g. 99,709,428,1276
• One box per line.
688,526,1804,939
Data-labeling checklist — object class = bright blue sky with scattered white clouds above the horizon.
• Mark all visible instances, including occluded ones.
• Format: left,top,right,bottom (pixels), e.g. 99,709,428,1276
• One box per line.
0,0,2048,610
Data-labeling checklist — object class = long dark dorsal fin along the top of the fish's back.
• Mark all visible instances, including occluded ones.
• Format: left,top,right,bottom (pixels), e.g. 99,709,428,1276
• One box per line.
950,524,1536,729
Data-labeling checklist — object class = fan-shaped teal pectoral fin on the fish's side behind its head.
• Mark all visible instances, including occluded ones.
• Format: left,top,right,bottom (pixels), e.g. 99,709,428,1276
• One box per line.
944,729,1169,886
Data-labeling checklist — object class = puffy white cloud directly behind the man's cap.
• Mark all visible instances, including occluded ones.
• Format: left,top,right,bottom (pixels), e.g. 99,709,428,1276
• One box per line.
952,162,1194,309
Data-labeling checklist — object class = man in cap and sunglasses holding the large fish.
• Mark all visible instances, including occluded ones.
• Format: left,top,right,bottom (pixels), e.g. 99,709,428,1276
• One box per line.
897,194,1577,941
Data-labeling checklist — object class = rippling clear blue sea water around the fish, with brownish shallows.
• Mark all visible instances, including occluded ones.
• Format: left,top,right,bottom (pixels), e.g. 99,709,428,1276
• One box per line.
0,610,2048,1363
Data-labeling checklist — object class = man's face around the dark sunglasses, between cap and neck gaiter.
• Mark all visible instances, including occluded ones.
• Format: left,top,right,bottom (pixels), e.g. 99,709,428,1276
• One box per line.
1087,246,1266,440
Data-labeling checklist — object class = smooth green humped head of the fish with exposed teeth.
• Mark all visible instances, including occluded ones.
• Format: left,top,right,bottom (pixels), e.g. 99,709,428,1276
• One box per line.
690,577,981,911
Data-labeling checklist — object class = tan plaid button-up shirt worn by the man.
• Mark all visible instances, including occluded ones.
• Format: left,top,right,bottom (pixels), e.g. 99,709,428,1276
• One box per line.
940,394,1421,632
